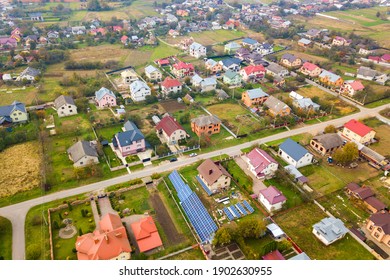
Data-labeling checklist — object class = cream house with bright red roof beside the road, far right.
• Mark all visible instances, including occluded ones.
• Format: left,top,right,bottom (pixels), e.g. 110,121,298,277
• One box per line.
342,119,375,144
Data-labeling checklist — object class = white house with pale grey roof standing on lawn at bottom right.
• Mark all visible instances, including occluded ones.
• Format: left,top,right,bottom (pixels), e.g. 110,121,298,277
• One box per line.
313,217,348,246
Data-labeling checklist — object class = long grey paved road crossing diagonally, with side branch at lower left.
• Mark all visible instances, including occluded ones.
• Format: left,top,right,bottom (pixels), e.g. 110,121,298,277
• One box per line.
0,105,390,259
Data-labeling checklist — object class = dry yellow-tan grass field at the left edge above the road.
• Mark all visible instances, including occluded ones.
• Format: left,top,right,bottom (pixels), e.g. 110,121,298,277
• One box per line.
0,141,42,197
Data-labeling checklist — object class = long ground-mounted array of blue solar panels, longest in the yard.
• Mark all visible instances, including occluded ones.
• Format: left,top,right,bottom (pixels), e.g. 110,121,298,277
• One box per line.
168,170,218,242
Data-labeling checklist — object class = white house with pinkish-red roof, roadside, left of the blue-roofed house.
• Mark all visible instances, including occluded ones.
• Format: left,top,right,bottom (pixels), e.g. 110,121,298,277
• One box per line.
246,148,279,179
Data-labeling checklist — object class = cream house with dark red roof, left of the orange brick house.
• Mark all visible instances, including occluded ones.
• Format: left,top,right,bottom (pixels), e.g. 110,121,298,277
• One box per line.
156,116,187,145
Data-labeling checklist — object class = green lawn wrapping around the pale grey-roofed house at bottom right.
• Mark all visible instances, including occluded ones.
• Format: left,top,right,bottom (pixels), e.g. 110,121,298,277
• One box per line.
274,203,374,260
